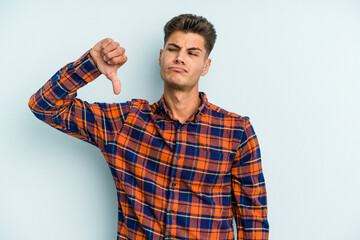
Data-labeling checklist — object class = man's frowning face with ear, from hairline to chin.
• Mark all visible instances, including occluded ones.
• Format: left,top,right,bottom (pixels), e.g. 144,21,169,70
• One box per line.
159,31,211,91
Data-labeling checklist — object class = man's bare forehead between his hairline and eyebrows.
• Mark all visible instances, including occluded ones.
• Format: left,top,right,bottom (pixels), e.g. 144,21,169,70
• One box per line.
165,31,205,50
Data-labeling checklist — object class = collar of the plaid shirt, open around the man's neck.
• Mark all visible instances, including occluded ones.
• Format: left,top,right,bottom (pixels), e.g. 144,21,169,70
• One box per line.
156,92,208,124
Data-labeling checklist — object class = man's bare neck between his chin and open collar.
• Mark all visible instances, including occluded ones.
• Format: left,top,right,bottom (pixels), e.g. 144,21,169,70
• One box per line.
164,87,201,123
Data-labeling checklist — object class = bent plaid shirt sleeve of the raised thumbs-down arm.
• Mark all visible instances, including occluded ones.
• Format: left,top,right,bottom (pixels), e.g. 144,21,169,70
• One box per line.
29,51,129,148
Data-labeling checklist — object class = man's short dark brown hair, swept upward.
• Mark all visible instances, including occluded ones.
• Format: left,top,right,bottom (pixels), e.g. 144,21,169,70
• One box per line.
164,14,216,55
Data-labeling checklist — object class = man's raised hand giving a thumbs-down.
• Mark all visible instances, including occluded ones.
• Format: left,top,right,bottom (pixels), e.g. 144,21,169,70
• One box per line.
90,38,127,94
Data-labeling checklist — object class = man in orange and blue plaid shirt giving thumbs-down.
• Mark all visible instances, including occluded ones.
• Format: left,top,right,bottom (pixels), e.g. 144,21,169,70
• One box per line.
29,14,268,240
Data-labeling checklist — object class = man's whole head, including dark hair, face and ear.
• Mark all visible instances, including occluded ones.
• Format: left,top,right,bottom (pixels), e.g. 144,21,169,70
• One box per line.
159,14,216,92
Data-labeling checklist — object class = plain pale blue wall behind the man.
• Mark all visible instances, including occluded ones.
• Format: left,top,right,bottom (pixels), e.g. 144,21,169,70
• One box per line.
0,0,360,240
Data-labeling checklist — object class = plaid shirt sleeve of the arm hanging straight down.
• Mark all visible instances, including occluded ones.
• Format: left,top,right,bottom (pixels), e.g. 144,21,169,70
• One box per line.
231,118,269,240
